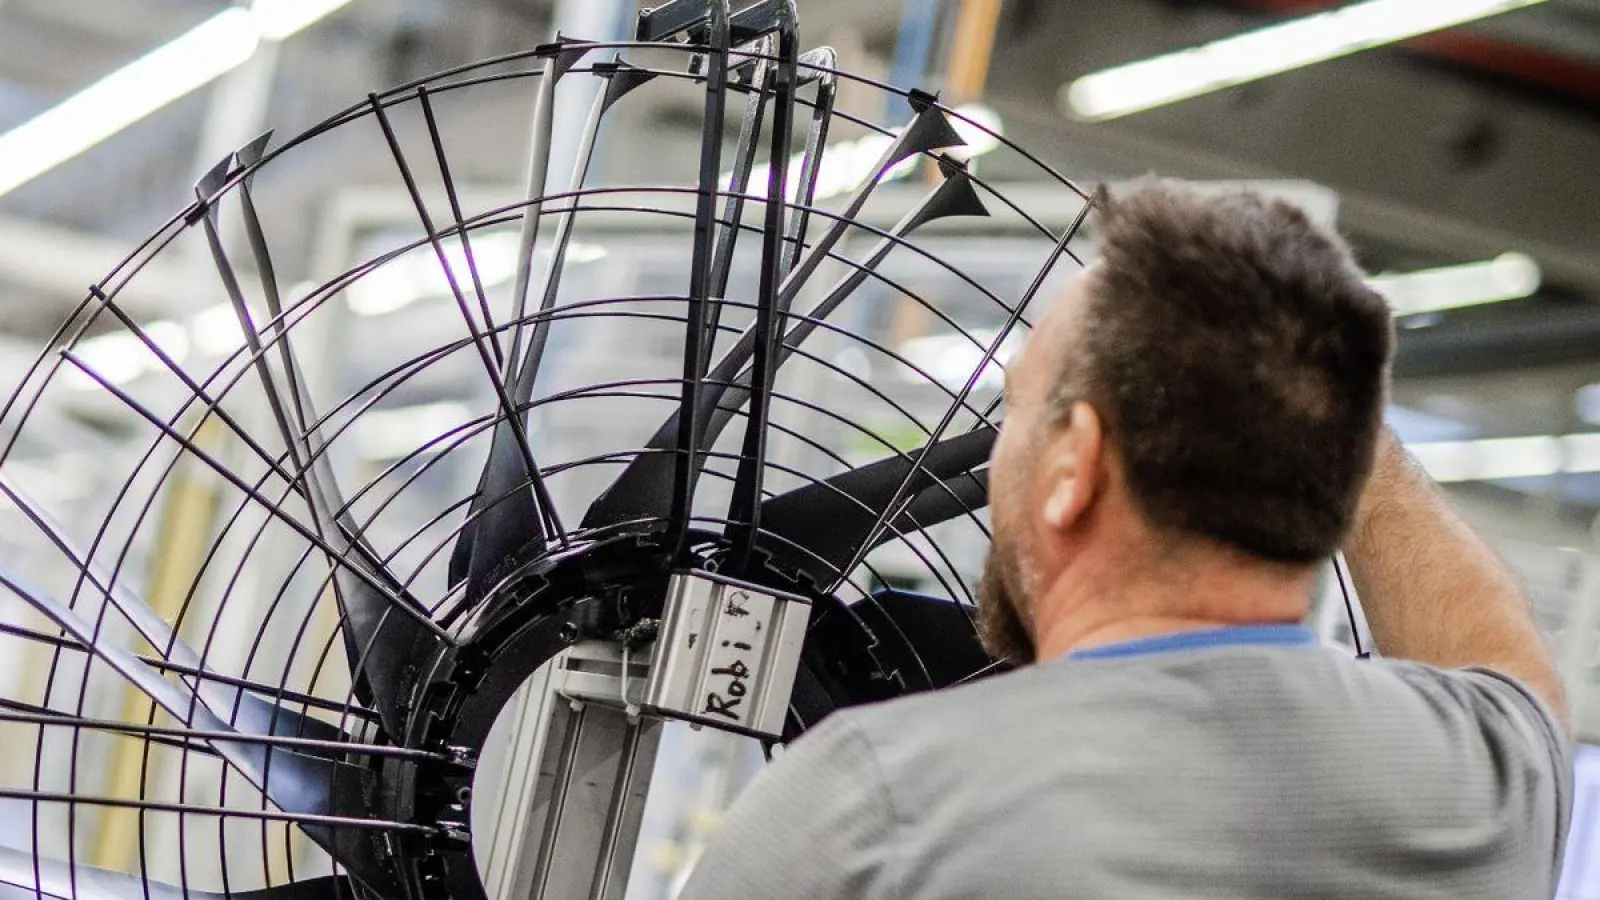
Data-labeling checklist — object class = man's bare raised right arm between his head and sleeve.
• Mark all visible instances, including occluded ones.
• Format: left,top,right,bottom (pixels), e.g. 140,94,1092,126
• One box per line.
1346,431,1570,724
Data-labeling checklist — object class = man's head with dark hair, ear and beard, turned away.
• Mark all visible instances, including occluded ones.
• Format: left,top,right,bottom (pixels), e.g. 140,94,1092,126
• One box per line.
979,179,1392,661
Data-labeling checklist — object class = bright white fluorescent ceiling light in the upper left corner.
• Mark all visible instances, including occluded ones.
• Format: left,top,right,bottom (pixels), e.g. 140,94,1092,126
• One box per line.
0,0,350,195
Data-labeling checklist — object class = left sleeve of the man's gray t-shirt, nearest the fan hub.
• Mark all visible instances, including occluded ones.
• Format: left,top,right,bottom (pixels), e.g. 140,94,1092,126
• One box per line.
680,713,893,900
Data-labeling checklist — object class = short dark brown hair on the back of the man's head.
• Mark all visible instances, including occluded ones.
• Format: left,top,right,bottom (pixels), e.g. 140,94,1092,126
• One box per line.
1059,178,1394,564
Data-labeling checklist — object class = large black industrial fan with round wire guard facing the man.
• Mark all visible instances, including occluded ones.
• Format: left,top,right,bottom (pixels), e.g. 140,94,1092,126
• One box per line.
0,0,1088,900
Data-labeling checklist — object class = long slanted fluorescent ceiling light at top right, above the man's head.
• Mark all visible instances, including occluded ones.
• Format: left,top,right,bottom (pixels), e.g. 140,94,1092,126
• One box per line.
1061,0,1544,122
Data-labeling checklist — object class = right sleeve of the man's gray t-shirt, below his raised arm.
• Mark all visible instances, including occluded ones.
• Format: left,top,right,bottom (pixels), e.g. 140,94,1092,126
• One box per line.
1418,666,1573,892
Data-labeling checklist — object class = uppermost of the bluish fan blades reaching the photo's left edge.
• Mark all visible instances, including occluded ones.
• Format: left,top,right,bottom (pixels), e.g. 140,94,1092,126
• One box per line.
0,472,349,740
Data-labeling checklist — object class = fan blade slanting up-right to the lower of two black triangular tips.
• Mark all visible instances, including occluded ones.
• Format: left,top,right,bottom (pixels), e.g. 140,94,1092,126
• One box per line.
582,164,986,528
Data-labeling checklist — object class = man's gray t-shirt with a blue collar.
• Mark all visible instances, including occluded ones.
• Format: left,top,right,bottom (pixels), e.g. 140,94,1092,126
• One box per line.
682,626,1571,900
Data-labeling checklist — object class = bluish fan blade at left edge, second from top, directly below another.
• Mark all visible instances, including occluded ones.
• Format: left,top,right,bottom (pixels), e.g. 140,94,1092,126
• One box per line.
0,565,395,889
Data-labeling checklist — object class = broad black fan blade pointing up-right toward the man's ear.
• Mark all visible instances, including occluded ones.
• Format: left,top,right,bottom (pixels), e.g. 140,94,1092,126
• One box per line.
762,428,995,585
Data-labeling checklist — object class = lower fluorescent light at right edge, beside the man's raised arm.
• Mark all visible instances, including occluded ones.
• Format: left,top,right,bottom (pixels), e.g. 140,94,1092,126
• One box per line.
1406,432,1600,484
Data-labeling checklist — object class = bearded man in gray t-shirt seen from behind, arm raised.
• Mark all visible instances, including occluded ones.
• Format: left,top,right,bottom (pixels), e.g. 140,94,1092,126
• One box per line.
683,181,1571,900
